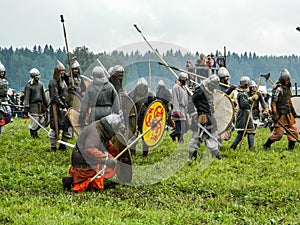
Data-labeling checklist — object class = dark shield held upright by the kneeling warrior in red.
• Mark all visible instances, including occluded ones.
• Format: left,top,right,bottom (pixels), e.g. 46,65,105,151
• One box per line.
112,133,132,183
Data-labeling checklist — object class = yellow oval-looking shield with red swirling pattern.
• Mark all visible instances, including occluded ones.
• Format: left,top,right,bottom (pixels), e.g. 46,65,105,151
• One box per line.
142,100,167,147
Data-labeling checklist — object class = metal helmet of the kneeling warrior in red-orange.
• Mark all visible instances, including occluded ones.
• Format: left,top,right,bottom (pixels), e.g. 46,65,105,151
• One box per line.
100,114,122,139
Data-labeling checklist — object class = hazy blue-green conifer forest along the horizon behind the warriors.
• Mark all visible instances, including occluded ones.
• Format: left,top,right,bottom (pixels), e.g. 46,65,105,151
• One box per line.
0,45,300,93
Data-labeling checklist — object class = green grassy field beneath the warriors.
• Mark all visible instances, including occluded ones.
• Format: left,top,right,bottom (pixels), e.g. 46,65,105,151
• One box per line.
0,119,300,225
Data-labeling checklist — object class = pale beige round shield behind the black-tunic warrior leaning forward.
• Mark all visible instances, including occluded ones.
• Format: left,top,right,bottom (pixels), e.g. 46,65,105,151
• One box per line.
214,90,235,135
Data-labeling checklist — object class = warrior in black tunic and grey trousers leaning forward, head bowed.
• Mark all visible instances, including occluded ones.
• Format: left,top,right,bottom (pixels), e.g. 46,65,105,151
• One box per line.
189,74,221,159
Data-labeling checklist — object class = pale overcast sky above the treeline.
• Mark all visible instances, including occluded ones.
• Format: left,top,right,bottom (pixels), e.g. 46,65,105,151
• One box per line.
0,0,300,55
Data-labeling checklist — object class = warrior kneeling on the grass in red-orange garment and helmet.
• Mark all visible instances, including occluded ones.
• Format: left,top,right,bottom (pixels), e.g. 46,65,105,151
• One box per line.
63,114,121,193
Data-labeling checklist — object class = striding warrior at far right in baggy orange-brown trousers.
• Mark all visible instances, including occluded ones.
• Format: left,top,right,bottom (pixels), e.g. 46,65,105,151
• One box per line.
263,69,298,150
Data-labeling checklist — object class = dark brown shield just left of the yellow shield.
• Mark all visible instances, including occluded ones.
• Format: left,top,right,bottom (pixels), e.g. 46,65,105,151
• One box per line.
120,93,137,139
